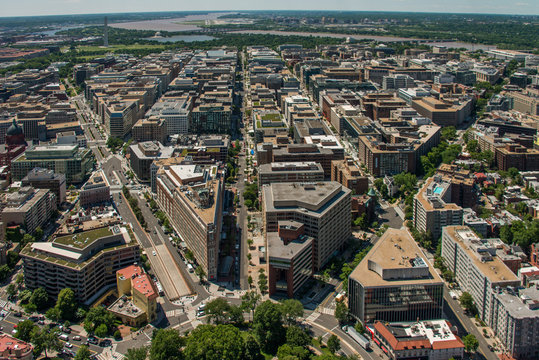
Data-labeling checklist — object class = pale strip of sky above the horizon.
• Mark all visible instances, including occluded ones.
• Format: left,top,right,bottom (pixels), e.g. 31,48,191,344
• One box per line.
0,0,539,16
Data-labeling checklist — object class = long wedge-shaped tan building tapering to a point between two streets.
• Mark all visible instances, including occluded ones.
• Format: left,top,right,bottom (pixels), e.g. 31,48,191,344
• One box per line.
156,165,224,280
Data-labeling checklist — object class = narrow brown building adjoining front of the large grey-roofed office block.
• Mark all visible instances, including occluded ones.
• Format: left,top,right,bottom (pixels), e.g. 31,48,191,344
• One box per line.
267,220,313,298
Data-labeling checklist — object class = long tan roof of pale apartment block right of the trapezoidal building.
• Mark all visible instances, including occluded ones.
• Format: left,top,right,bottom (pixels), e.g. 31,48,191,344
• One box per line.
443,226,519,283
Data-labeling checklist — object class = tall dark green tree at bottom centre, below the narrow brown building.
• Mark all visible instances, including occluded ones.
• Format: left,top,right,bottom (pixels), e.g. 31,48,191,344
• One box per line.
253,300,285,352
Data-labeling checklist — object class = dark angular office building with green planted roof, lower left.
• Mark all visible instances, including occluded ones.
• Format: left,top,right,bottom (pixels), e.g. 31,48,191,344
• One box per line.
20,225,140,305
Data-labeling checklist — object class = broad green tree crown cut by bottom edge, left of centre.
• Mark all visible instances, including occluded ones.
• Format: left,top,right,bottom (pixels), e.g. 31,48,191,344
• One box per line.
184,325,245,360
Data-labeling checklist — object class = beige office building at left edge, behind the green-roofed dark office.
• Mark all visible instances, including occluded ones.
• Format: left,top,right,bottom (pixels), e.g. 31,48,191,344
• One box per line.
2,186,56,234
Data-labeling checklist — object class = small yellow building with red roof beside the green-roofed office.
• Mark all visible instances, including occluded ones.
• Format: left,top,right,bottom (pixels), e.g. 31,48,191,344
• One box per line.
108,265,158,327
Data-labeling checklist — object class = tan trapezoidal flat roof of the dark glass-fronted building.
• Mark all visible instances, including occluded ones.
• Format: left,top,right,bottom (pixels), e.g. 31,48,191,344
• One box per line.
350,228,442,287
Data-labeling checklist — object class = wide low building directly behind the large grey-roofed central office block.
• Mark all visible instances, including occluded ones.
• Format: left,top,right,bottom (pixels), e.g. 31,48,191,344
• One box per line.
258,162,324,186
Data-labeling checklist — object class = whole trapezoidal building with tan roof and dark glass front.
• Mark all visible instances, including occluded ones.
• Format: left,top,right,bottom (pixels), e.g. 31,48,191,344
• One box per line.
348,228,444,324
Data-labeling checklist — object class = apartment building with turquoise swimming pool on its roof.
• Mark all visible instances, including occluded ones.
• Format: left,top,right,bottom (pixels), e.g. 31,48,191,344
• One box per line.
413,175,463,239
